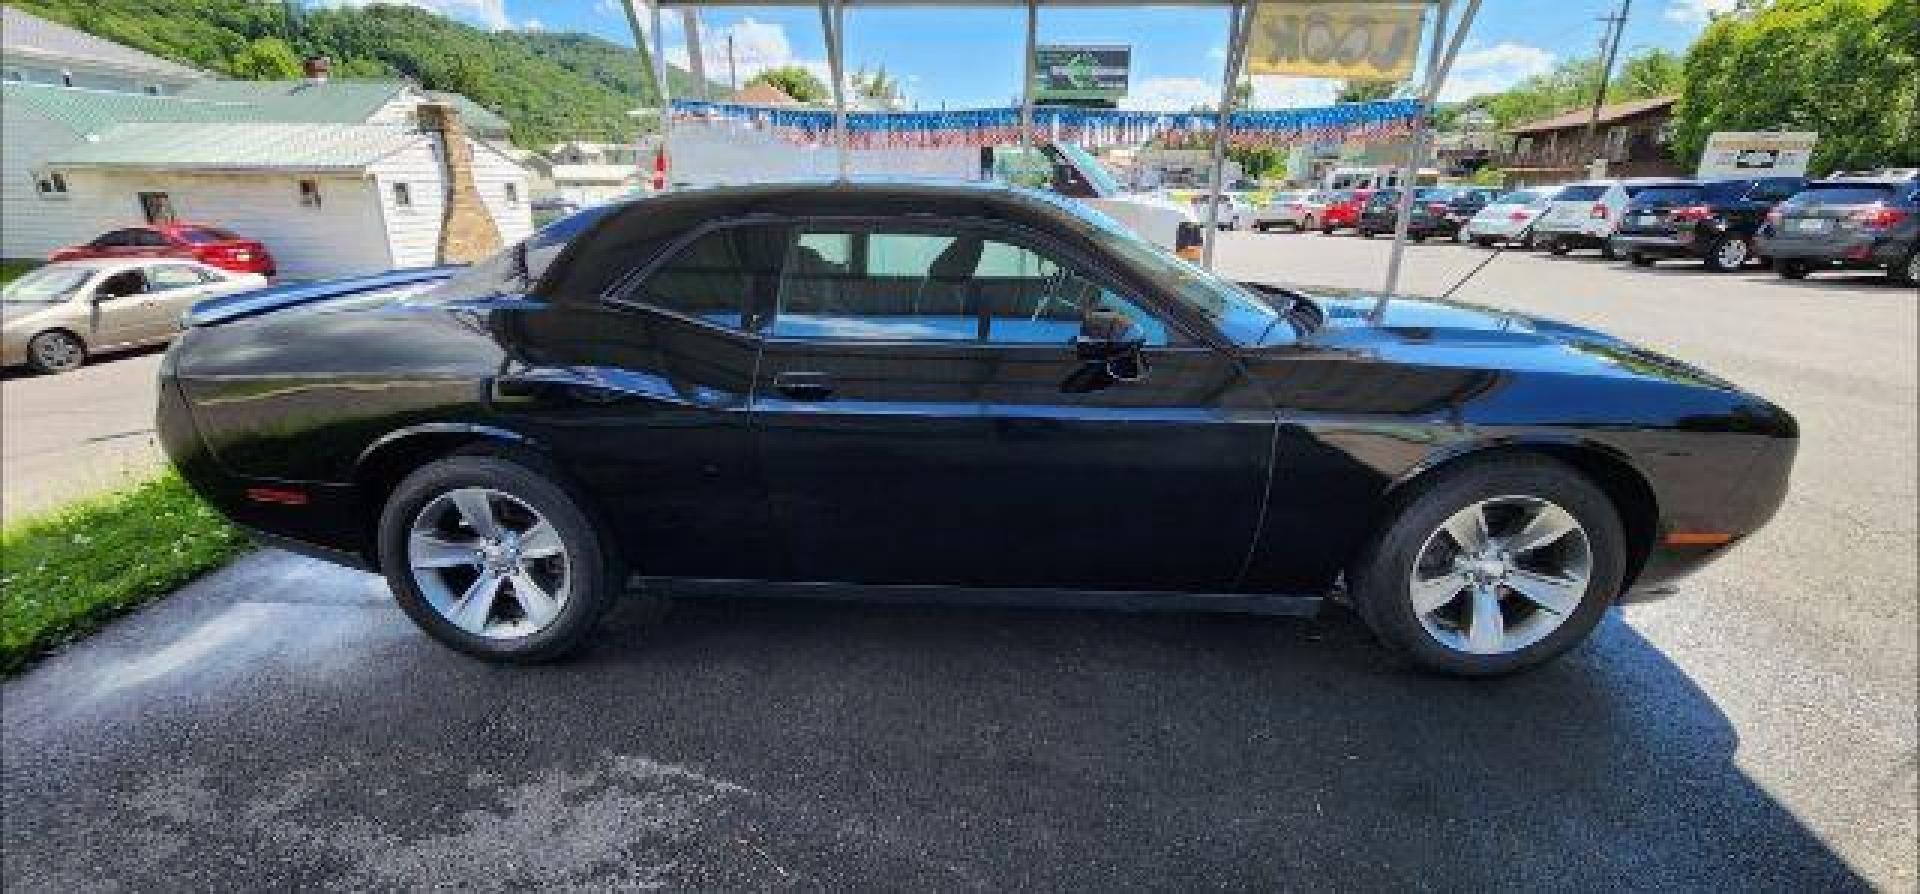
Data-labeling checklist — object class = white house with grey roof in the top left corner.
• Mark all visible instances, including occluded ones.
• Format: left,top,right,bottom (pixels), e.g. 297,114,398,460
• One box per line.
0,6,209,96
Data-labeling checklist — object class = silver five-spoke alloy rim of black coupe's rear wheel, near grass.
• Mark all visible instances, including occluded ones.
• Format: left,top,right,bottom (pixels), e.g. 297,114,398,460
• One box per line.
407,487,572,639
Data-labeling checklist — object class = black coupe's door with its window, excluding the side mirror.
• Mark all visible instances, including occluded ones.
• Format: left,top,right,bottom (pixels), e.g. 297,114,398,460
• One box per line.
753,223,1273,589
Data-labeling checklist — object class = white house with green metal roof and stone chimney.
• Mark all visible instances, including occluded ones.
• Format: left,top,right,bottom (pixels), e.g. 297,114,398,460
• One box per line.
0,40,532,278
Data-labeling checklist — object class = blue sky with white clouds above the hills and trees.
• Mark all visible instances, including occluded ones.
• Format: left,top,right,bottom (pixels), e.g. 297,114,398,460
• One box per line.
323,0,1734,109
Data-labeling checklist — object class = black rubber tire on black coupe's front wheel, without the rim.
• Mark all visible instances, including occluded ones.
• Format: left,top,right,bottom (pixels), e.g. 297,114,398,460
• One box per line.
1348,453,1626,677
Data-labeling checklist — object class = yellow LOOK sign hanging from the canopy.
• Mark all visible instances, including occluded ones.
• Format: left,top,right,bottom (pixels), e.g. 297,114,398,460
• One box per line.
1246,0,1427,81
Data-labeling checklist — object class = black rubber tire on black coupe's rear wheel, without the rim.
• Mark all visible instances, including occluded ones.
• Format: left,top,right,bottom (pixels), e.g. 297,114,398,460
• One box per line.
380,457,626,664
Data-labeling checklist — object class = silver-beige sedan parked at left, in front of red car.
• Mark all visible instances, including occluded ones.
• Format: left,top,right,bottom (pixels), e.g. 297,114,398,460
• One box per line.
0,257,267,372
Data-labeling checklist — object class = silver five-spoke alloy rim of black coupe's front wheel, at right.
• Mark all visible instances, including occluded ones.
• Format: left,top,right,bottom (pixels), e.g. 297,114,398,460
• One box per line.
1407,497,1594,654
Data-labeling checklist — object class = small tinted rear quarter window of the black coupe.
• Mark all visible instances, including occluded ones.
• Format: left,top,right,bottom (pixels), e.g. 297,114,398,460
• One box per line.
634,226,787,328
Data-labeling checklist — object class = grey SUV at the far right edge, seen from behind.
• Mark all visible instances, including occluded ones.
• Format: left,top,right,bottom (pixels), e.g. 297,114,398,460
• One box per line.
1759,178,1920,284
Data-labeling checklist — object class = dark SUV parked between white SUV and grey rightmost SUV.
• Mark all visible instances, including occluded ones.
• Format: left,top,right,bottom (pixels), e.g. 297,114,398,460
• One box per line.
1613,176,1807,272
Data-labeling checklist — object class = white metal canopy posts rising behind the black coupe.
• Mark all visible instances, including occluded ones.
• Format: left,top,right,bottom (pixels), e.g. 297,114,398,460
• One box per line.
620,0,1480,322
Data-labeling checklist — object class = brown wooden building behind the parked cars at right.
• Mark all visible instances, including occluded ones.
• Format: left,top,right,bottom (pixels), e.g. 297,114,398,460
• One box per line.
1494,96,1686,186
